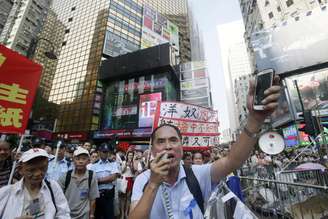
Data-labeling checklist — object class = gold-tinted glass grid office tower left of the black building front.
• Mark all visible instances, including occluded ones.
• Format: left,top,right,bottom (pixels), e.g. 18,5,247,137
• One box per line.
44,0,109,132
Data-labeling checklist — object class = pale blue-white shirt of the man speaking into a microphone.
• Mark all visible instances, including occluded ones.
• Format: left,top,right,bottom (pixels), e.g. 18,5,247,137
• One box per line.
131,164,212,219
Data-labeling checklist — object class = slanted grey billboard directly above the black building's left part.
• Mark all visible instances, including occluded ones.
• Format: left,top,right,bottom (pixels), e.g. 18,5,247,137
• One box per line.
103,30,139,57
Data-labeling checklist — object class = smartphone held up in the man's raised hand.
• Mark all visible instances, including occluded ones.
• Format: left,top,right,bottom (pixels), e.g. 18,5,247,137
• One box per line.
253,69,274,110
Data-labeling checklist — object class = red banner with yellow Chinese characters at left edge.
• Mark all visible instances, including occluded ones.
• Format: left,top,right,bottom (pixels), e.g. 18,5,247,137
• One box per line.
0,45,42,134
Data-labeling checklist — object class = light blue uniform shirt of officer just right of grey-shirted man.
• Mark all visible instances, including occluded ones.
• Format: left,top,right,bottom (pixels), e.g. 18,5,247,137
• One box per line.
90,160,119,190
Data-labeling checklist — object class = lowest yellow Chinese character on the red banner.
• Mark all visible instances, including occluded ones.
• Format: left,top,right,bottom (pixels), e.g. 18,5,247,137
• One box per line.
0,108,23,128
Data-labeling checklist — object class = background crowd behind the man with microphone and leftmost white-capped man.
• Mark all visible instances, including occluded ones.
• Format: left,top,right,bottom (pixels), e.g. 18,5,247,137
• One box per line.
0,139,228,218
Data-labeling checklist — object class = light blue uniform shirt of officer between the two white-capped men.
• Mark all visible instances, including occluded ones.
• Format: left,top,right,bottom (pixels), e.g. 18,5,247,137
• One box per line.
47,158,73,181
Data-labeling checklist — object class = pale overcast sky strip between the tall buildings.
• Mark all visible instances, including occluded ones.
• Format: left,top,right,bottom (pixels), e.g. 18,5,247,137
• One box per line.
189,0,242,137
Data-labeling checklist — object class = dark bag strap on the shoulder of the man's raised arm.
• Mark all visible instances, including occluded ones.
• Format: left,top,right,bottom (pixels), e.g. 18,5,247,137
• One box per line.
183,165,205,215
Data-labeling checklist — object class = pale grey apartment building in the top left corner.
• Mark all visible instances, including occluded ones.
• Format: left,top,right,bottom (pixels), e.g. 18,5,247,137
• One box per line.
0,0,51,55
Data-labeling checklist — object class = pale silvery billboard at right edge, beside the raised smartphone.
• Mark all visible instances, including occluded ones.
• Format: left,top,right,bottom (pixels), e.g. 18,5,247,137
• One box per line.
285,69,328,119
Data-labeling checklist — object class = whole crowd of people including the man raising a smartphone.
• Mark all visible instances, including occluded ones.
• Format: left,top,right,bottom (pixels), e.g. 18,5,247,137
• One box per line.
0,77,280,219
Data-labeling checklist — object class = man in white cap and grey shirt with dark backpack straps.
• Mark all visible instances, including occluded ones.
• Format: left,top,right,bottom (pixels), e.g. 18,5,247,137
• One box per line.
59,147,99,219
